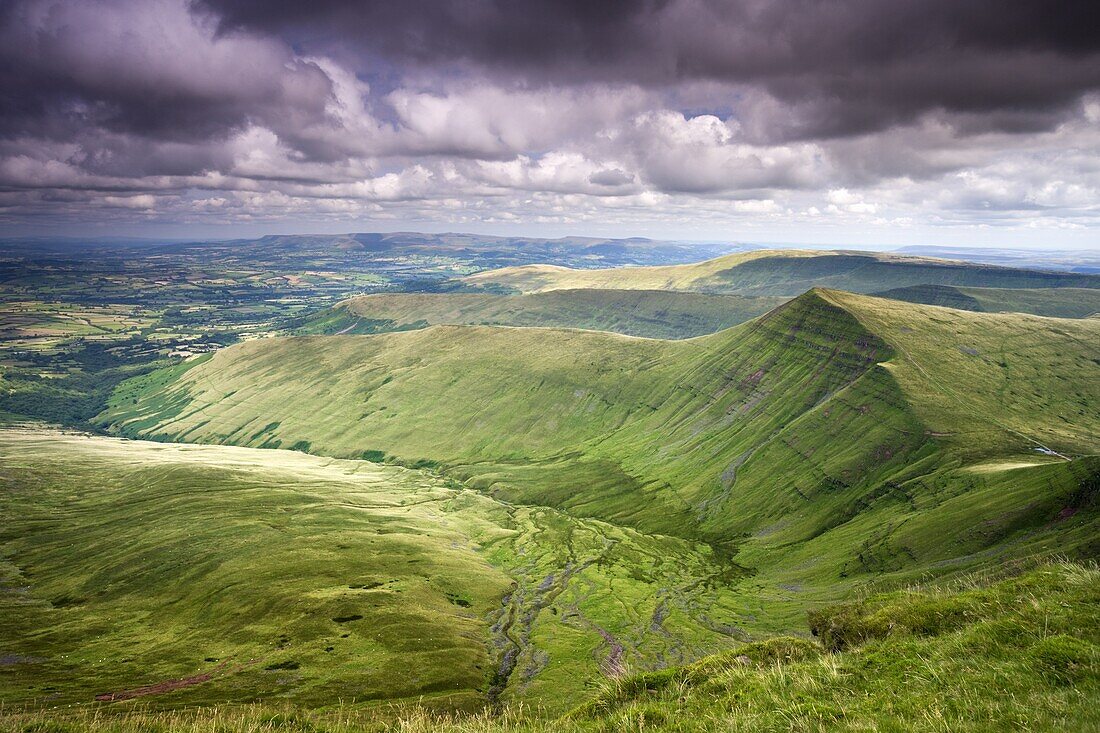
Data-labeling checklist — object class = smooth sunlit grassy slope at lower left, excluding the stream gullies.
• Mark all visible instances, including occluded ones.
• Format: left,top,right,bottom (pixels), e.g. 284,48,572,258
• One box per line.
0,431,509,704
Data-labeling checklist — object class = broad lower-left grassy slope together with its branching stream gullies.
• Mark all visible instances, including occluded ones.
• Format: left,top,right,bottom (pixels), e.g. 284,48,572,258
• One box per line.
0,429,755,709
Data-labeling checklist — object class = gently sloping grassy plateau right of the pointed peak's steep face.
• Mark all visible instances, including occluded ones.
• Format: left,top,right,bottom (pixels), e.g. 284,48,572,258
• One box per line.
828,293,1100,455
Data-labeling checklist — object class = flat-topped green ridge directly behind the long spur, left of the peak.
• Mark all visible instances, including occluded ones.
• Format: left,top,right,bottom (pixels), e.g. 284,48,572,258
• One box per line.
288,288,785,339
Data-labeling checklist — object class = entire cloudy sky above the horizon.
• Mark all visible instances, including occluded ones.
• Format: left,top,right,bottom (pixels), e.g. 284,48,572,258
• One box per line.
0,0,1100,248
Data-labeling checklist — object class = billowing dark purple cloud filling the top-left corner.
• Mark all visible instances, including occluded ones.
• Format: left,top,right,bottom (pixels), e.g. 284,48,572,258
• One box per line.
0,0,331,158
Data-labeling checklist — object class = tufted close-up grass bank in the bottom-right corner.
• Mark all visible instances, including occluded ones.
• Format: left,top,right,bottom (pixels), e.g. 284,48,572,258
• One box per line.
576,564,1100,731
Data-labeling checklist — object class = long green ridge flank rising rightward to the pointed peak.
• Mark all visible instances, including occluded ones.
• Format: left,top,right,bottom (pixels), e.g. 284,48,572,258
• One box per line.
101,294,902,533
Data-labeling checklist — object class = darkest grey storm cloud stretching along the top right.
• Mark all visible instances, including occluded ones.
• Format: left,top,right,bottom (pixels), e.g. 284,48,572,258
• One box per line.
200,0,1100,138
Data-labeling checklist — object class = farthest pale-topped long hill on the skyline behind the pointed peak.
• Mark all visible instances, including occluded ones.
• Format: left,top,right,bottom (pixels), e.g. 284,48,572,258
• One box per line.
463,250,1100,297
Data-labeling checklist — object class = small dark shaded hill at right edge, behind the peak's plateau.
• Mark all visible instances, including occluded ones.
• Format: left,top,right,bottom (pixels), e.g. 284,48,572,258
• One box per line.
876,280,1100,318
